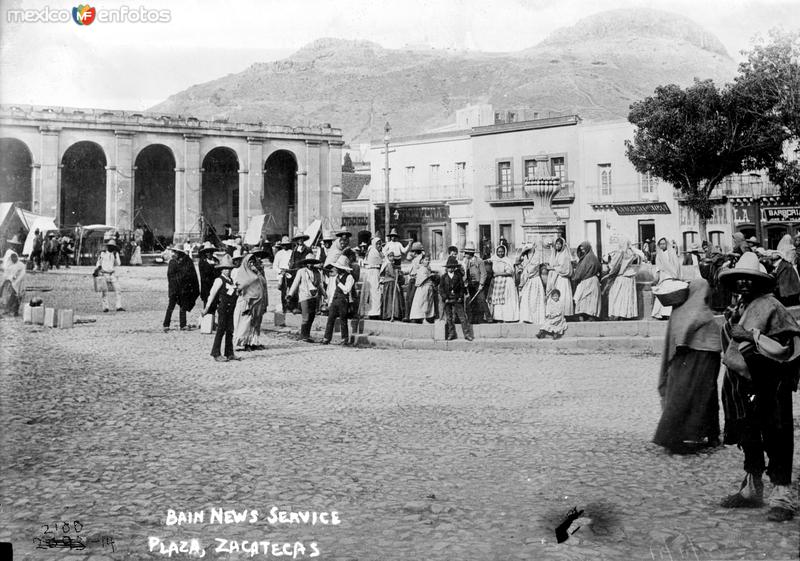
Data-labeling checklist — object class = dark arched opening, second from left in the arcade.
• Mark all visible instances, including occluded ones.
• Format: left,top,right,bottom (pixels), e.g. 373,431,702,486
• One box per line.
60,141,106,227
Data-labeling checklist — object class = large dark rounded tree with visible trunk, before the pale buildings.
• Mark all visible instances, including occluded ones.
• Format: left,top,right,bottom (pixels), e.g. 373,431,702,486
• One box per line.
625,80,786,240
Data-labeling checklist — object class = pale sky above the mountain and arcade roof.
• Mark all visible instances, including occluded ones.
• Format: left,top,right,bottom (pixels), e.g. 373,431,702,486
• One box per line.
0,0,800,110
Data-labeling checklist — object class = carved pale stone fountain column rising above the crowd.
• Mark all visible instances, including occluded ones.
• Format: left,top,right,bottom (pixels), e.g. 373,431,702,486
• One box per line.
522,155,564,257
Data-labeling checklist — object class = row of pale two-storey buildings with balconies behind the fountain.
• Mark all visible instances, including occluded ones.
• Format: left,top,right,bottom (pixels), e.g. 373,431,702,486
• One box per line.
370,115,800,258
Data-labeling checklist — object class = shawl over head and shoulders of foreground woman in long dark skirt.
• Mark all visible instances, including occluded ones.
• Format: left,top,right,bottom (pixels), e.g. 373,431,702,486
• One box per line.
661,279,722,390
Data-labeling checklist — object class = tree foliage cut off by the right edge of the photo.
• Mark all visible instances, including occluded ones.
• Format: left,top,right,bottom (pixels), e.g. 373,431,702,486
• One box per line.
735,30,800,200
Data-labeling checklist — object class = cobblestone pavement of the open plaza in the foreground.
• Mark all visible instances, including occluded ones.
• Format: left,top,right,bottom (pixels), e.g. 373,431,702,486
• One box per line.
0,270,800,561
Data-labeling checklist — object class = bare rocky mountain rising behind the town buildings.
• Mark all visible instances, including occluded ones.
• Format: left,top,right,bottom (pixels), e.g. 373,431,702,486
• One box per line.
151,9,736,143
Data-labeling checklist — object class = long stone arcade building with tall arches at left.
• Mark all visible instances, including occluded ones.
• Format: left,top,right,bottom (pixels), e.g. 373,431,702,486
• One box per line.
0,106,343,245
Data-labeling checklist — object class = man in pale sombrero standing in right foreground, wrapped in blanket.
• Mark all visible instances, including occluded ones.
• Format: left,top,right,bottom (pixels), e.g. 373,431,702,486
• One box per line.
719,252,800,522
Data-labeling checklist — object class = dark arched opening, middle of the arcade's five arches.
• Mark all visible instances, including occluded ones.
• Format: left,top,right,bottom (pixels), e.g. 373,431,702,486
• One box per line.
133,144,175,245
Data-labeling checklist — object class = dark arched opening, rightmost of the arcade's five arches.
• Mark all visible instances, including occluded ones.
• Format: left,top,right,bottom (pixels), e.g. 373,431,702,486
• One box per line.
261,150,298,238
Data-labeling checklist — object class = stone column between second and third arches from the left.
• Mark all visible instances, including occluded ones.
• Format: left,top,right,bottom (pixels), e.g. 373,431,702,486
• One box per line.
111,131,134,232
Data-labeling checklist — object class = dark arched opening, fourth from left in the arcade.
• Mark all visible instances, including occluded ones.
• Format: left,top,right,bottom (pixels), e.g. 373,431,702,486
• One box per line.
202,148,239,233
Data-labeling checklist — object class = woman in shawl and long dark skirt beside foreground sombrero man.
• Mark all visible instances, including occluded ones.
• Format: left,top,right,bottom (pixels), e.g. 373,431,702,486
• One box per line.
653,279,722,453
